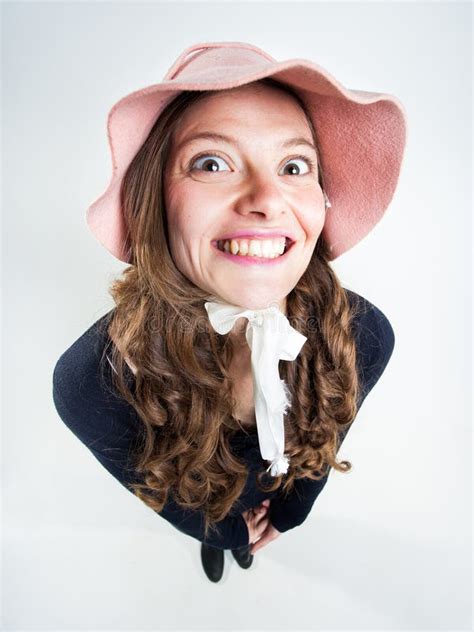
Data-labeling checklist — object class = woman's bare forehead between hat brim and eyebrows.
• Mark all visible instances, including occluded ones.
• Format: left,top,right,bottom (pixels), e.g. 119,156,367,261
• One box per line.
173,84,312,150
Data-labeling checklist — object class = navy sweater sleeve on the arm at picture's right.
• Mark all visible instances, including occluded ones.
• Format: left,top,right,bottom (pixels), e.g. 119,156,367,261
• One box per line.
269,289,395,533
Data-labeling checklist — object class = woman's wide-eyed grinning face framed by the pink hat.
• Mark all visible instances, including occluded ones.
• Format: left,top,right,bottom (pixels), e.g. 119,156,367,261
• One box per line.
164,84,325,313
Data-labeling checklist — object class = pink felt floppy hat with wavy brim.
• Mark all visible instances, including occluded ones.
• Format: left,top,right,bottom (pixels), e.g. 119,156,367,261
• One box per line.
86,42,407,263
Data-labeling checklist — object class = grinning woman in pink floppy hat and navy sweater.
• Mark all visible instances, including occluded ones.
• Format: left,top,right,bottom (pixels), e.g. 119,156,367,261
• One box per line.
53,42,405,581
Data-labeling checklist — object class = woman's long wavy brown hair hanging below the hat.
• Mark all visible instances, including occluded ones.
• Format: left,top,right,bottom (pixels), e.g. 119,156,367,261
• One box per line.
101,78,359,536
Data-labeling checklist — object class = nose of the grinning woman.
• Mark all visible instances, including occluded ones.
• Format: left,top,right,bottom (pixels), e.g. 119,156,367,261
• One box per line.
235,171,288,221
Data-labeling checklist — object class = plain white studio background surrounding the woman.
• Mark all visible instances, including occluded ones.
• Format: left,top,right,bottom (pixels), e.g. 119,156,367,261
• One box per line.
2,2,472,631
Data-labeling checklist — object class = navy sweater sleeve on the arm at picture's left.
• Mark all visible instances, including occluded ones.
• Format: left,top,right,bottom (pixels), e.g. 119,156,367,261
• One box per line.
52,314,249,549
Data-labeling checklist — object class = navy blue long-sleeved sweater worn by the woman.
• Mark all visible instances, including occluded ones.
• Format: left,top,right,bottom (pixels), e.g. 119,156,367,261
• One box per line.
53,289,395,549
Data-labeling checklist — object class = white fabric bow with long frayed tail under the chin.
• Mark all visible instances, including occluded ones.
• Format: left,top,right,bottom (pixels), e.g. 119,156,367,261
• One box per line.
204,302,307,476
